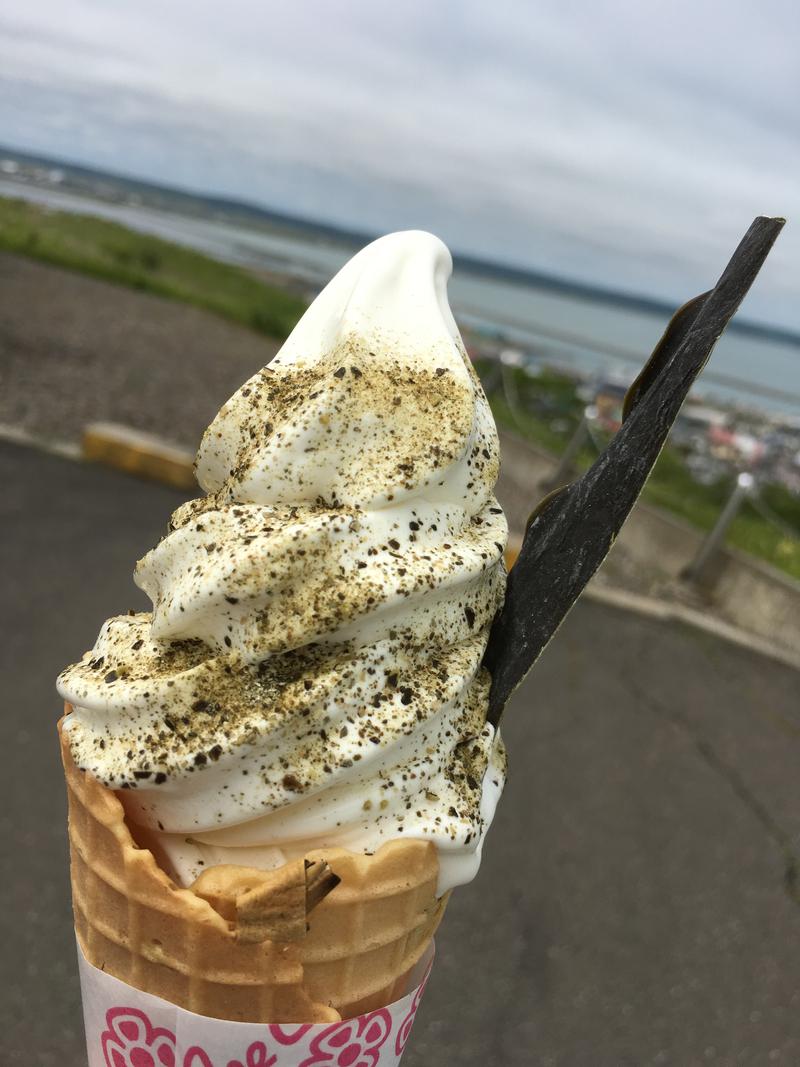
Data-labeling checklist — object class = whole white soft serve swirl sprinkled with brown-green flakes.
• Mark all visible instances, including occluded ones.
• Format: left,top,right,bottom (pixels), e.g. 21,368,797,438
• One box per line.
59,232,507,892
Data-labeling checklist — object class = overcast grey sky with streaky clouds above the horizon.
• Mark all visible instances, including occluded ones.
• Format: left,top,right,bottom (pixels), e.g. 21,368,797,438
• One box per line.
0,0,800,329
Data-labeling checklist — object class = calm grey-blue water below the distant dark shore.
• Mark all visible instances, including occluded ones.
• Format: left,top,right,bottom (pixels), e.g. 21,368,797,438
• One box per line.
6,179,800,415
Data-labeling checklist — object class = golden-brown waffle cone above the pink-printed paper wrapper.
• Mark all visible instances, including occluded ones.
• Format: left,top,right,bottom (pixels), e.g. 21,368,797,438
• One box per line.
62,731,447,1022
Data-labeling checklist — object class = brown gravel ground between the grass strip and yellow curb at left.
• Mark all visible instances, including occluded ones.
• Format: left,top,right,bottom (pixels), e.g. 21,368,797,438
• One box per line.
0,253,277,448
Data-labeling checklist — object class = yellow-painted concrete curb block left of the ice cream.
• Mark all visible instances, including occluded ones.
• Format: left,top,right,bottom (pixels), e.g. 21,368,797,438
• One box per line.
81,423,197,489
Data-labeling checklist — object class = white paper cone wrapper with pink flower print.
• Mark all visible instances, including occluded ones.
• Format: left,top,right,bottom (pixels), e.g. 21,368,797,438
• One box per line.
78,944,433,1067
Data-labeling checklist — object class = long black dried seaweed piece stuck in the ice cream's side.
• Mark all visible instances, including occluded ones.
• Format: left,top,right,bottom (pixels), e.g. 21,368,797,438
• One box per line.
483,218,784,726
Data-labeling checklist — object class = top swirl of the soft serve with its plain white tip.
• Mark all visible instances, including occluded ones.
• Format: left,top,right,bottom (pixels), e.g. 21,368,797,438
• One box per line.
196,232,496,509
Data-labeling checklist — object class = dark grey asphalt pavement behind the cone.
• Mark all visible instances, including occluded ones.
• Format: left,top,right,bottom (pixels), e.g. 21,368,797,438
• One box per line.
0,444,800,1067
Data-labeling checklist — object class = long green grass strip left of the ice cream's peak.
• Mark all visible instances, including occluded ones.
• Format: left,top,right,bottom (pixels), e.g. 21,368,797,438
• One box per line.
0,197,305,339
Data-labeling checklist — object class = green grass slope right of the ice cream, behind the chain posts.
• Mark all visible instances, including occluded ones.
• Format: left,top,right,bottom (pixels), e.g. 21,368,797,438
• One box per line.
476,363,800,578
